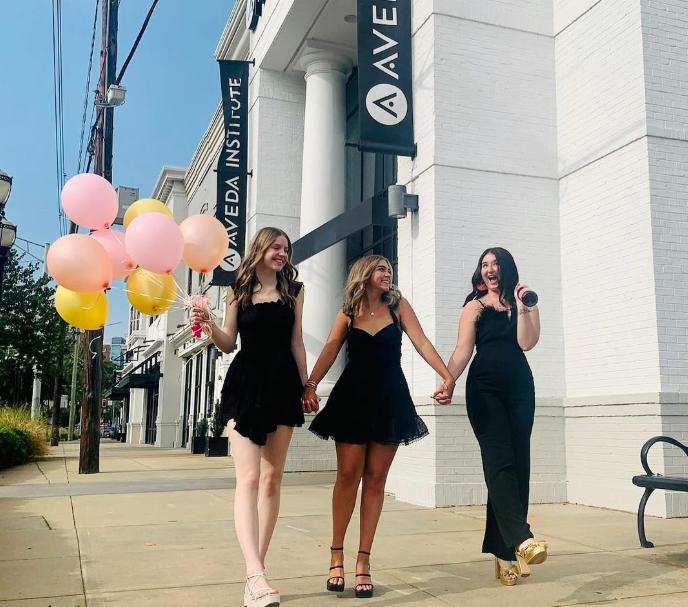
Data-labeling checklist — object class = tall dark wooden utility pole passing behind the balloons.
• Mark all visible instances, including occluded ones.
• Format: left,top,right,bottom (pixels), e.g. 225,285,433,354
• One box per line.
79,0,119,474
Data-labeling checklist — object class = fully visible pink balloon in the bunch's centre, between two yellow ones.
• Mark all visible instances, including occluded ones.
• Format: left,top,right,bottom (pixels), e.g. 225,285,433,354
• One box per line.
124,213,184,274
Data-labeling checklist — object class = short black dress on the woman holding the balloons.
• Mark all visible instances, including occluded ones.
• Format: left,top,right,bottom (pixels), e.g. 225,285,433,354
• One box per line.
221,285,304,445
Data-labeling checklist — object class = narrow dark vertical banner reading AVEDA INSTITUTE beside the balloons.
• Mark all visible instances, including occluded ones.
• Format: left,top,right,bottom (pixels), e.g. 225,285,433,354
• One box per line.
211,60,249,286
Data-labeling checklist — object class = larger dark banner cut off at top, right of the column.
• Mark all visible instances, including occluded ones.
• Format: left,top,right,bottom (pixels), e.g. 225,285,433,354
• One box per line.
358,0,416,156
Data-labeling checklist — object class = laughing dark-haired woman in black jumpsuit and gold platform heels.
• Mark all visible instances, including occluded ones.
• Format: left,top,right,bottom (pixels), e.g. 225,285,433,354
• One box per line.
437,247,547,586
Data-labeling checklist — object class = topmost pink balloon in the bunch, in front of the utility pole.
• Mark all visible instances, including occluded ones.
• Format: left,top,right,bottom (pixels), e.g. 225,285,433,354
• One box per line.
61,173,119,230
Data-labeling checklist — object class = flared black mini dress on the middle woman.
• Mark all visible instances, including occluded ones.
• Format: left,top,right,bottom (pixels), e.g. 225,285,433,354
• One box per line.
310,309,428,445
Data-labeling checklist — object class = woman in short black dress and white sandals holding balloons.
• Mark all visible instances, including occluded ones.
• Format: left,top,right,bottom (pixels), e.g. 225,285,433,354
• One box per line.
191,228,306,607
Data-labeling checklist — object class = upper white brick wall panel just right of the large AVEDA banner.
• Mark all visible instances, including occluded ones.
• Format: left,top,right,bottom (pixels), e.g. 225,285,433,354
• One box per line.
434,17,557,178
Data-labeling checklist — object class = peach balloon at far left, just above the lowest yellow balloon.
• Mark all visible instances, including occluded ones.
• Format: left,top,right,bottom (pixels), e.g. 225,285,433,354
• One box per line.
47,234,112,293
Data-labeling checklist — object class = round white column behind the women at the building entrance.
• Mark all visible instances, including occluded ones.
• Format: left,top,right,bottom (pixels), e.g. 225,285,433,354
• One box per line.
299,51,351,396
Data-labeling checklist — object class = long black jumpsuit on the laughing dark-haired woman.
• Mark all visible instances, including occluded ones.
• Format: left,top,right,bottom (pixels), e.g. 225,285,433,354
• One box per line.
466,300,535,561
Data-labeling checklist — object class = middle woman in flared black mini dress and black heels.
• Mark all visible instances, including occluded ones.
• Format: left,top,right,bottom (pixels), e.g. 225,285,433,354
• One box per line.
303,255,454,598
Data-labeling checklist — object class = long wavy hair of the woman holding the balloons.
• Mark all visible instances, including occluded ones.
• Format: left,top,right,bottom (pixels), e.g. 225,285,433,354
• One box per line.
233,228,300,308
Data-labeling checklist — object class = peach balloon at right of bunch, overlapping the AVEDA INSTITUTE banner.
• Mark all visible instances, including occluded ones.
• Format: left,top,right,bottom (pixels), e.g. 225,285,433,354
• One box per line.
179,215,229,274
